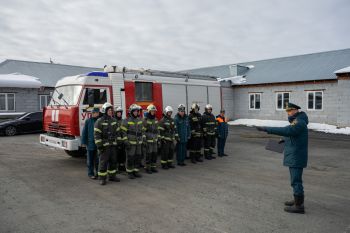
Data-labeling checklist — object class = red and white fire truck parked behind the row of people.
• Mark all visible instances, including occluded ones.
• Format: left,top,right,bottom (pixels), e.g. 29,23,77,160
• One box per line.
39,66,222,157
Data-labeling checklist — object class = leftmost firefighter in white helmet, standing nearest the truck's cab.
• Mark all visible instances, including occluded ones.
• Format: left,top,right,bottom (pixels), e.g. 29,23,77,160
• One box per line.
94,103,120,185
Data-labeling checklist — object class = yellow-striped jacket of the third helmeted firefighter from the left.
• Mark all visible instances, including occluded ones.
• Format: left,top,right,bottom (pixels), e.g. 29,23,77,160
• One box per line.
120,114,144,146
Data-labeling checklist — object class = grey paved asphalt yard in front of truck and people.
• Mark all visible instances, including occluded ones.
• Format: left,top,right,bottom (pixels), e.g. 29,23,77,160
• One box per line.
0,126,350,233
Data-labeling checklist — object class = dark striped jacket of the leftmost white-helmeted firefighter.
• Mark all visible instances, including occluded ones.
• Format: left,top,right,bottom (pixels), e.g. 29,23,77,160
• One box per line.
94,115,117,150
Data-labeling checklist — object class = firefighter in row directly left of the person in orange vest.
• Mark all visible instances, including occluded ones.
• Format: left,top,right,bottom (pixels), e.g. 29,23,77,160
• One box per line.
202,104,217,160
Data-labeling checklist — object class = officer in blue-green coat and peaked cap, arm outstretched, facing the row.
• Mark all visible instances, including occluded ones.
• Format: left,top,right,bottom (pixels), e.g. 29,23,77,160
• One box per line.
257,103,309,214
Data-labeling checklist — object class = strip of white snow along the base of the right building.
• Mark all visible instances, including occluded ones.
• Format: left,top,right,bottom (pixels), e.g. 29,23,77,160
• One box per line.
228,119,350,135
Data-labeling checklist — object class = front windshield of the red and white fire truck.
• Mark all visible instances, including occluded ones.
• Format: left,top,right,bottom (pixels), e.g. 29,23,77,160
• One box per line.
49,85,82,106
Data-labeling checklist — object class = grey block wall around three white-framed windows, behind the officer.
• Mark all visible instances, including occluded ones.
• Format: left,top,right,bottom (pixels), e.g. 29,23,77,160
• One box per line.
233,81,338,125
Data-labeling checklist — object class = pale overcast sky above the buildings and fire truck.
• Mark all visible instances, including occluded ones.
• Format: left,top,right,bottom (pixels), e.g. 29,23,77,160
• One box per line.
0,0,350,70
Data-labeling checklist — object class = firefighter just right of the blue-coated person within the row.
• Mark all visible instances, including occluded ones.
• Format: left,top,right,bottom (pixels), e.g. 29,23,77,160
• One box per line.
188,103,203,163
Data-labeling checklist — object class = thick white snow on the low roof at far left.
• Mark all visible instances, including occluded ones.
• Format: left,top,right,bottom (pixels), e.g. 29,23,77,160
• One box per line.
0,73,42,88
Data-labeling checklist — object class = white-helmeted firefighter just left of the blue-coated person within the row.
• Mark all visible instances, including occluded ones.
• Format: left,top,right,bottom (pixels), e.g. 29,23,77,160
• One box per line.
159,106,178,169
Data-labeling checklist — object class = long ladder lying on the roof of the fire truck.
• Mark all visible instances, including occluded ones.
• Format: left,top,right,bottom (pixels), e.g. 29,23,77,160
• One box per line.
104,66,219,81
